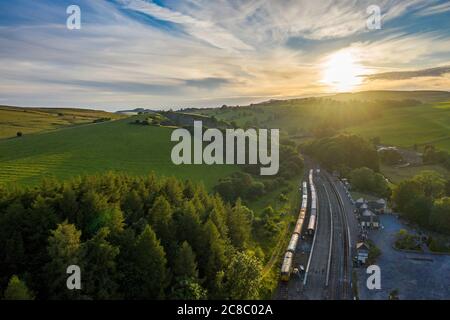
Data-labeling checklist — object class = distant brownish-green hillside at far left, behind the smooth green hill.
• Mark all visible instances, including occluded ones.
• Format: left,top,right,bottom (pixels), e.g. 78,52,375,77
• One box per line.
0,106,124,139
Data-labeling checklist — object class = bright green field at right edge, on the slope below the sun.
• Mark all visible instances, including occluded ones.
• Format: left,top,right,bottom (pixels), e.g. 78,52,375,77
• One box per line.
345,102,450,152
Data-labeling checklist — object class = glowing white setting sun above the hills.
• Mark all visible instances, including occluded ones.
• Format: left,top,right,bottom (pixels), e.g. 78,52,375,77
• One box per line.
321,50,367,92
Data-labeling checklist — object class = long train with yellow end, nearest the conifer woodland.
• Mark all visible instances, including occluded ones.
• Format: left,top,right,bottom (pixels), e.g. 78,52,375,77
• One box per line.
280,181,308,281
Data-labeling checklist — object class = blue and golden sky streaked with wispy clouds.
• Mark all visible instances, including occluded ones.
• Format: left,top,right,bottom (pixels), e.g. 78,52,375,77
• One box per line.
0,0,450,111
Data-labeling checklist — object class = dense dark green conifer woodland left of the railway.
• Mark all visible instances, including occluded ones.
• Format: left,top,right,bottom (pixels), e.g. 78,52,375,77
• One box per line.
0,173,273,299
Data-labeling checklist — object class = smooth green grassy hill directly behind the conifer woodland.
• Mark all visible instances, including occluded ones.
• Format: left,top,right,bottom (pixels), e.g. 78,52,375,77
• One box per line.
0,118,238,187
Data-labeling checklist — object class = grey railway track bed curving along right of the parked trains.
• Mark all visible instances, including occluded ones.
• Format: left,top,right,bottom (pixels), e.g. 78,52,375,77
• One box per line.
278,171,351,300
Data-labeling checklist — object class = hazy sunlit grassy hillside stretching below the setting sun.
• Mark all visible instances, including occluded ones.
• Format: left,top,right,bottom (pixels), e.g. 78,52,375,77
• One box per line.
197,91,450,152
